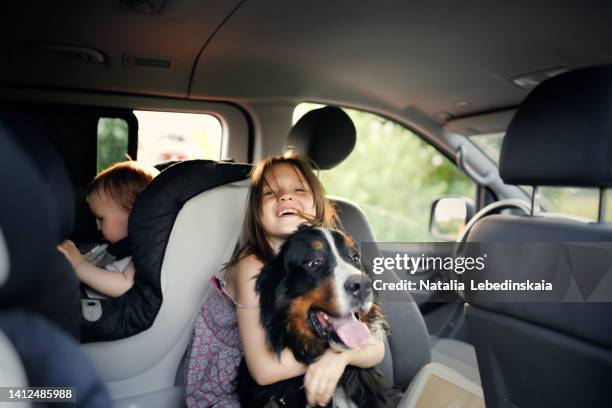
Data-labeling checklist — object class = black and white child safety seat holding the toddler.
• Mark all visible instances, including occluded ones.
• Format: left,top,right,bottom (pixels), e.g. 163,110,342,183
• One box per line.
83,160,250,408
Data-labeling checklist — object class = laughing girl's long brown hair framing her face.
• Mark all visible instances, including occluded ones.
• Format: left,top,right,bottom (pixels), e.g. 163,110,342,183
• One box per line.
226,150,340,267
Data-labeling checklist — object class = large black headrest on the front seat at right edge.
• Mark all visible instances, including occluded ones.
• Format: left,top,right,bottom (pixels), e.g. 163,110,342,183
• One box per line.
499,65,612,187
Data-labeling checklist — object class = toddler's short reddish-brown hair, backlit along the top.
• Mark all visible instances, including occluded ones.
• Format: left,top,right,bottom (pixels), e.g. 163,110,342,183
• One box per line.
87,160,159,211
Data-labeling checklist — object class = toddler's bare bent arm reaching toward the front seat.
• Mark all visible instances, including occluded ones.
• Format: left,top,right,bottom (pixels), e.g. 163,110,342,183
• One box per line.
58,240,135,297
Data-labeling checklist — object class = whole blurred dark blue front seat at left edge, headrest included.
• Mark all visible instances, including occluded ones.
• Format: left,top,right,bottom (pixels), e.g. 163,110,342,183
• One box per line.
0,128,111,408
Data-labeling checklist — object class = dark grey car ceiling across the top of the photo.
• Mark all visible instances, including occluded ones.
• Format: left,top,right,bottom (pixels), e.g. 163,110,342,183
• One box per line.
0,0,612,126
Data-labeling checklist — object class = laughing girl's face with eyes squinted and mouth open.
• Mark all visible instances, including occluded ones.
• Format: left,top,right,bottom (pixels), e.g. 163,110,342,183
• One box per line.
261,163,316,250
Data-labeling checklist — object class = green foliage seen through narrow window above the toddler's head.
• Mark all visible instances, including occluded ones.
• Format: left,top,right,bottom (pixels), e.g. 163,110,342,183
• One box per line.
97,118,128,173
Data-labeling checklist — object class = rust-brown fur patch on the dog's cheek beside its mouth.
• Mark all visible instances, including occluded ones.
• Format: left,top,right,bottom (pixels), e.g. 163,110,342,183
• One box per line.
287,279,335,353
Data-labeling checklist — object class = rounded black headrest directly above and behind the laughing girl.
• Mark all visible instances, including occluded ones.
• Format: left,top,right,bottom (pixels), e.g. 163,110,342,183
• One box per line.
287,106,357,170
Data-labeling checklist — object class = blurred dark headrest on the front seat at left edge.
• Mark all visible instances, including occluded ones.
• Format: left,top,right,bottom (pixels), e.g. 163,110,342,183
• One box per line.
0,129,79,337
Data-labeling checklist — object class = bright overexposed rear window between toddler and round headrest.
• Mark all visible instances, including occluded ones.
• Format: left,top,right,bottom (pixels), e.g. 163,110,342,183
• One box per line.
134,111,222,166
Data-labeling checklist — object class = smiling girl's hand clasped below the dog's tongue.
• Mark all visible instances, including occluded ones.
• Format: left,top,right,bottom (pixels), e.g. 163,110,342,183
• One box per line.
304,349,348,406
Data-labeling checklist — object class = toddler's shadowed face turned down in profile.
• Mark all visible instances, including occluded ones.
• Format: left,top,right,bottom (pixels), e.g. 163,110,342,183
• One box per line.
87,189,130,244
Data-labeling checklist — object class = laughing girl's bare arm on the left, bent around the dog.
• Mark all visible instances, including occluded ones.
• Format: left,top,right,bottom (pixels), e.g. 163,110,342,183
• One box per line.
233,256,306,385
